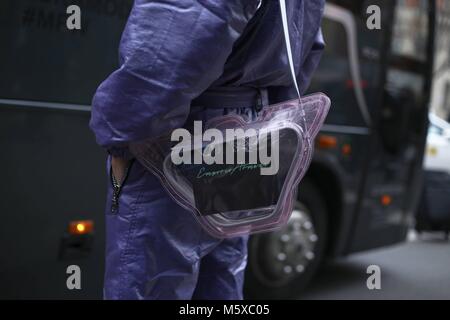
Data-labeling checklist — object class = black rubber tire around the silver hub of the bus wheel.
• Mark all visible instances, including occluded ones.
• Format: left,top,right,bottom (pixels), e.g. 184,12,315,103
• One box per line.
244,180,327,299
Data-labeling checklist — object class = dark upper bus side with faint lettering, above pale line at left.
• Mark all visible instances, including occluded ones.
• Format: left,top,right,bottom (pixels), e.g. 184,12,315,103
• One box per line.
0,0,132,104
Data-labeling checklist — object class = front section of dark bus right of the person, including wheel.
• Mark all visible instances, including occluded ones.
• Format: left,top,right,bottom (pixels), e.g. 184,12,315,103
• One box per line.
246,0,436,298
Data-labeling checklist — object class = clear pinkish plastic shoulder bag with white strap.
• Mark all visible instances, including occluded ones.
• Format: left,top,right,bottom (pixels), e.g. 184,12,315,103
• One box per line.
130,0,330,238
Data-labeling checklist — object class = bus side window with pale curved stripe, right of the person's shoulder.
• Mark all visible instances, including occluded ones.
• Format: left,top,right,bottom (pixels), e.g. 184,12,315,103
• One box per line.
310,0,389,127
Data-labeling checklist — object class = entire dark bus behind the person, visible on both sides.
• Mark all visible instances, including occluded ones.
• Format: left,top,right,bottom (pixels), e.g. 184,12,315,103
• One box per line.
0,0,436,299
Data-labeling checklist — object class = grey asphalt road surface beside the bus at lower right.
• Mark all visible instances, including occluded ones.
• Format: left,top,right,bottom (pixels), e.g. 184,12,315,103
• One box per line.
300,233,450,299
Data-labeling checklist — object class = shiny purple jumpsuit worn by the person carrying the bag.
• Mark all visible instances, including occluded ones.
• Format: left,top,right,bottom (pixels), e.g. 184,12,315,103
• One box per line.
90,0,324,299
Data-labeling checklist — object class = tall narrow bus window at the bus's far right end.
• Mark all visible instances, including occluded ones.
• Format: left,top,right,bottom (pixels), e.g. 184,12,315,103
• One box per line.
380,0,429,153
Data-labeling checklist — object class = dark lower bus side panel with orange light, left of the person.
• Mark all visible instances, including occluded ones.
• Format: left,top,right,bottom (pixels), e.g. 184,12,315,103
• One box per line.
0,104,107,299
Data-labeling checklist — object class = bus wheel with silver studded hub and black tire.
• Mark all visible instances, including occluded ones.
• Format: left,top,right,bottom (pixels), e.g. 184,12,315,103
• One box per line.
245,180,327,299
